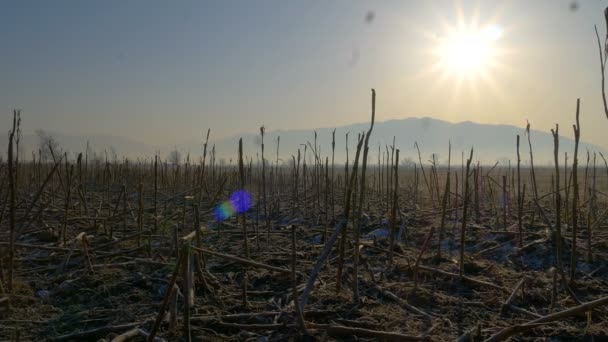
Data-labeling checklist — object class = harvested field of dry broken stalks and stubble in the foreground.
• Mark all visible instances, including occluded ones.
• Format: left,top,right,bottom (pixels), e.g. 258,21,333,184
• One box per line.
0,97,608,341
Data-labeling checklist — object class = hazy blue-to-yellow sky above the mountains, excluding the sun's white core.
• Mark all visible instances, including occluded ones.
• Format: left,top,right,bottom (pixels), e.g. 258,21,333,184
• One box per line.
0,0,608,146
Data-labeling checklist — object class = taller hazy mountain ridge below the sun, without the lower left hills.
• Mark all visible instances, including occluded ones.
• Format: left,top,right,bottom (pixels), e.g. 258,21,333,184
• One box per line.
198,117,605,165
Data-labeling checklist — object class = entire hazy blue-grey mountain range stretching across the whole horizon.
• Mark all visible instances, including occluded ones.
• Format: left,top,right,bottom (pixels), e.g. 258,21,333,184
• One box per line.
0,117,606,165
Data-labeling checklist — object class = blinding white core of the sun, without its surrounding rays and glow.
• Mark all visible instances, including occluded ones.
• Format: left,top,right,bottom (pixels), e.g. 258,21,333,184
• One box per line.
435,25,502,79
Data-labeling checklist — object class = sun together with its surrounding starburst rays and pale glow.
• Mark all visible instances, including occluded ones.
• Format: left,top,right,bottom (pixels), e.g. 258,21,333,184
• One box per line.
414,0,510,111
